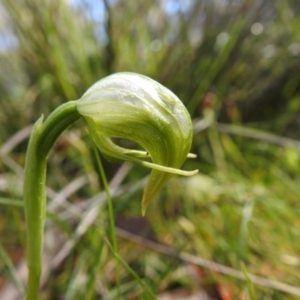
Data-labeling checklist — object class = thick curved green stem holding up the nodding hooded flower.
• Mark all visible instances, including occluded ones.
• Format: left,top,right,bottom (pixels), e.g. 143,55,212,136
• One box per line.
24,101,81,300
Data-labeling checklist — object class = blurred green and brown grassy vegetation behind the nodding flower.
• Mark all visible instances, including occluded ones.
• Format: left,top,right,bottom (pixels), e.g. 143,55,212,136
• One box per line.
0,0,300,299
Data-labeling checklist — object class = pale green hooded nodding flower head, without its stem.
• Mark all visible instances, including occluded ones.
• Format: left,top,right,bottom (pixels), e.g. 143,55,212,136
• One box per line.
77,73,197,214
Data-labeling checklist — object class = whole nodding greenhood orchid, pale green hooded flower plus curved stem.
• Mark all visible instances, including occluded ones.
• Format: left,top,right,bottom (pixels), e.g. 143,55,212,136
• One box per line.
24,73,197,300
